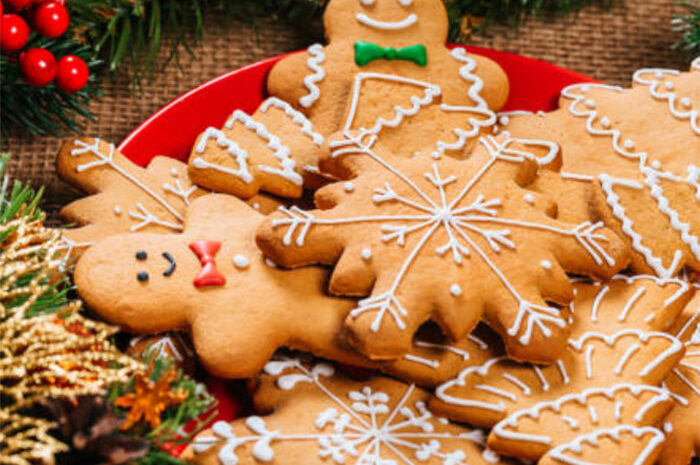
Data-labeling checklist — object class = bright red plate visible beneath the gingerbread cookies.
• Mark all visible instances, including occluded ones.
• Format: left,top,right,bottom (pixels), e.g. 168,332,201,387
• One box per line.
119,47,594,434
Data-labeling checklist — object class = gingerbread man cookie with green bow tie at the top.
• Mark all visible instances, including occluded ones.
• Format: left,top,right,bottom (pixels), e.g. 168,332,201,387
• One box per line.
268,0,508,154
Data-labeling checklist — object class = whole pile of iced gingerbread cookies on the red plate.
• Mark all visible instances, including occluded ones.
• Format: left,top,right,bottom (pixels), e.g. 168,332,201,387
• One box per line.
58,0,700,465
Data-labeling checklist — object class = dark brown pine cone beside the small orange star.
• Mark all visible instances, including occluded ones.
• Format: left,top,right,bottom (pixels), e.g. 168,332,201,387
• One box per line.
43,396,149,465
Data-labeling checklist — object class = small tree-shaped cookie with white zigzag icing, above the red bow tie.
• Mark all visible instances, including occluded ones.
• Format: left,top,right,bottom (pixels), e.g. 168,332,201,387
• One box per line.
188,97,324,199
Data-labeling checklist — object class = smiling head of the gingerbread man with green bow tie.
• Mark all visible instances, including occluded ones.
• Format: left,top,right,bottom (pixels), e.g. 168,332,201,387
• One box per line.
323,0,448,47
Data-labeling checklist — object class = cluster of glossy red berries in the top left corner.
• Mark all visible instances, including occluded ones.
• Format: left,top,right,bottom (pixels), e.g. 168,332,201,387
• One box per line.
0,0,90,92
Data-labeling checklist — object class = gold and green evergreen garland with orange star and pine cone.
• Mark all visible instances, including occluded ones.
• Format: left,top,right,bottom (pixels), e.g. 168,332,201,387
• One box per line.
0,154,213,465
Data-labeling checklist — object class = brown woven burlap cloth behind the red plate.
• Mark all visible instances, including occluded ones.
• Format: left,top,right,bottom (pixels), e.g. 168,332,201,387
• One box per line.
6,0,689,218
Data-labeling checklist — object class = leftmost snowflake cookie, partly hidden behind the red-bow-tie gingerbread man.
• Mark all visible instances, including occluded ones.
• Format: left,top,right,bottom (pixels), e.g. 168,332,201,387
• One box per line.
56,138,282,263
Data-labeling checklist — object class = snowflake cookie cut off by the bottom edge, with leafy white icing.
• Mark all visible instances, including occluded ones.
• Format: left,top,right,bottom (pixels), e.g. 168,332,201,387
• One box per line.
183,359,501,465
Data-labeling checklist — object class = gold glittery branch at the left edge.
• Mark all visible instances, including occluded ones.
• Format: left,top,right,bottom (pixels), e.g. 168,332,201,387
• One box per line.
0,199,143,465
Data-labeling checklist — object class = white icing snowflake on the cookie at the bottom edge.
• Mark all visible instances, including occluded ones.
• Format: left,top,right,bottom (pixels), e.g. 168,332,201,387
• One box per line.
194,359,497,465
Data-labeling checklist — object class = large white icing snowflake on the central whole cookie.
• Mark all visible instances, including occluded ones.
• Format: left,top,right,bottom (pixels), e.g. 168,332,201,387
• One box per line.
271,132,615,345
